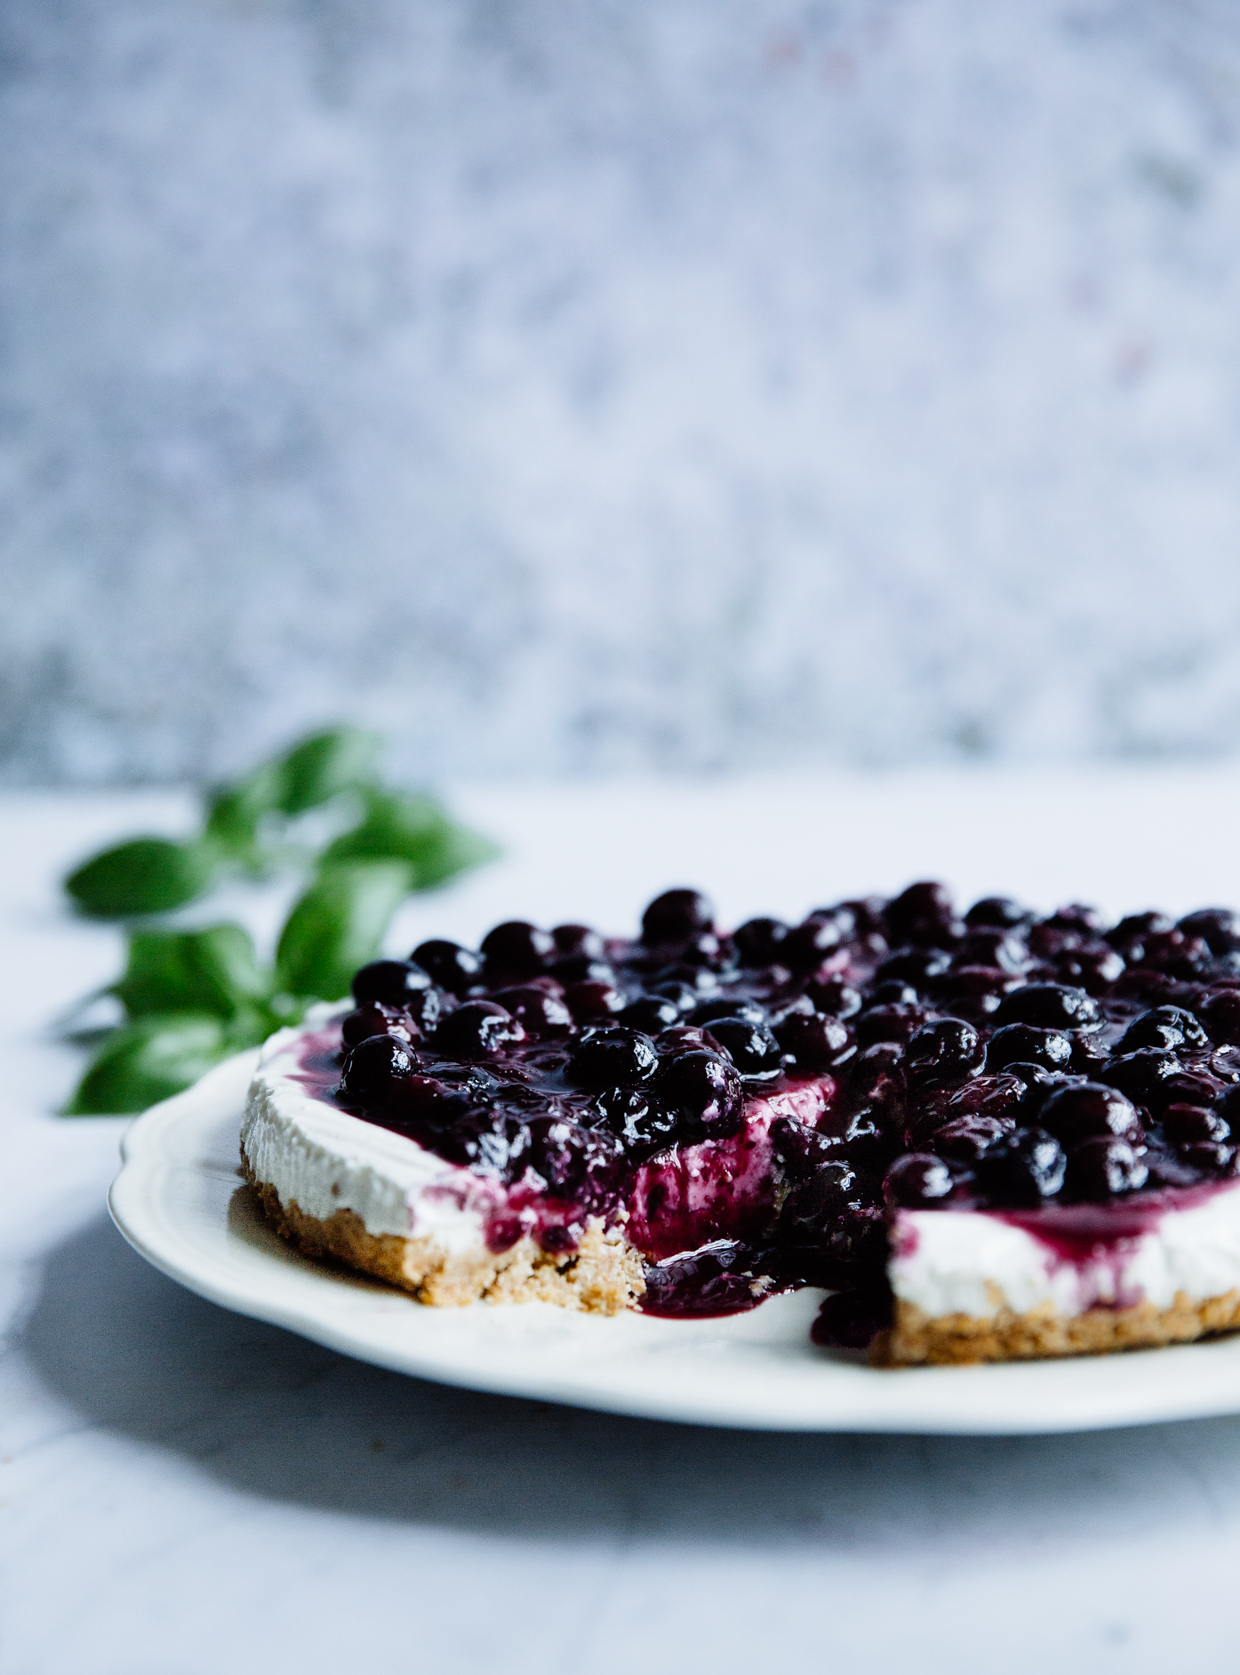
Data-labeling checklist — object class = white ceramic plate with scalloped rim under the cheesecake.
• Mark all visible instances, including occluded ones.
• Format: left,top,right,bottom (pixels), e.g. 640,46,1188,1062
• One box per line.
109,1054,1240,1434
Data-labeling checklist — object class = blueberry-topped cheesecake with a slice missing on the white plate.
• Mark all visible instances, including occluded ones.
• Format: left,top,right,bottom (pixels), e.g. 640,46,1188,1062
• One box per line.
241,883,1240,1365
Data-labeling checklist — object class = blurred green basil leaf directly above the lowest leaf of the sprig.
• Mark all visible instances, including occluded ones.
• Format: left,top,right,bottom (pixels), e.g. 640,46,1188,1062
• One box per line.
112,925,271,1018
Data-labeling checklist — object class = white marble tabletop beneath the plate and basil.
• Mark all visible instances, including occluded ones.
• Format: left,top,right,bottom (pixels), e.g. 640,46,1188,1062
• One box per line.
0,772,1240,1675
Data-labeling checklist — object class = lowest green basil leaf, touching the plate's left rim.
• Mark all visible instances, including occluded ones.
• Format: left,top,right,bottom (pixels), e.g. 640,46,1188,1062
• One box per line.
65,1013,230,1117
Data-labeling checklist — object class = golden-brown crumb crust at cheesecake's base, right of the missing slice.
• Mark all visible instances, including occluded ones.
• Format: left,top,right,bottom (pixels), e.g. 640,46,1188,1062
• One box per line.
870,1290,1240,1367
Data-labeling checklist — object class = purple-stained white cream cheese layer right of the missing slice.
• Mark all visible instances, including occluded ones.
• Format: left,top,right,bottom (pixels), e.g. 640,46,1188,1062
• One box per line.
888,1183,1240,1318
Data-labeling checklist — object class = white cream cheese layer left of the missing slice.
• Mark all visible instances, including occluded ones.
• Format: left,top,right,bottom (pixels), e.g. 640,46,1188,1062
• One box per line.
241,1007,498,1253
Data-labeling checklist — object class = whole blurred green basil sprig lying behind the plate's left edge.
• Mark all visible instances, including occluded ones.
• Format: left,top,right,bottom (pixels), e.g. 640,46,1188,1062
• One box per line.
65,729,499,1116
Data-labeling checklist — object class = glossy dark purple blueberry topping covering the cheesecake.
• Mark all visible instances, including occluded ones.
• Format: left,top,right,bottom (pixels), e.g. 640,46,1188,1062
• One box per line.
266,883,1240,1345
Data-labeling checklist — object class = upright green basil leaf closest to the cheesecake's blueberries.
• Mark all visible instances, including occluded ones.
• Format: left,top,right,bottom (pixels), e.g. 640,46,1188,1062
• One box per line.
275,861,409,1000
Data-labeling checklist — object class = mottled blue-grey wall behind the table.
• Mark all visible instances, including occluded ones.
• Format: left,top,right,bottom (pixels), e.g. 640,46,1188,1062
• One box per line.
0,0,1240,782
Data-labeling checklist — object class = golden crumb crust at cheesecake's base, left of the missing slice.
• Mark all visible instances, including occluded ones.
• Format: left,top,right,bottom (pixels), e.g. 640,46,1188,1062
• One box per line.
241,1149,645,1315
